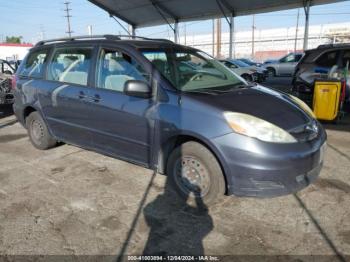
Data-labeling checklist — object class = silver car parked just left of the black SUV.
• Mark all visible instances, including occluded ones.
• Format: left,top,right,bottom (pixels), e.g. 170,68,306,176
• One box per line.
265,53,303,76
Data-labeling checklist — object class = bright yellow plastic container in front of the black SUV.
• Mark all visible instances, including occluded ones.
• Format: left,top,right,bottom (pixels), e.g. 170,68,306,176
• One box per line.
313,81,341,121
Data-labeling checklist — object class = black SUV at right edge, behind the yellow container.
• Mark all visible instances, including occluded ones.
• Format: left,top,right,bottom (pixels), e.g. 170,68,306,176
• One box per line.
292,43,350,100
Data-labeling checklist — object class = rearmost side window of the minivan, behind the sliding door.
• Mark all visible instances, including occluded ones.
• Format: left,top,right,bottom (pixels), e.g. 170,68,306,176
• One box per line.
19,50,48,78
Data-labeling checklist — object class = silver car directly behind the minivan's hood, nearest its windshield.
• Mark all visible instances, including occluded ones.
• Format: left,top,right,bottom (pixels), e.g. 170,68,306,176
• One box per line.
220,59,266,83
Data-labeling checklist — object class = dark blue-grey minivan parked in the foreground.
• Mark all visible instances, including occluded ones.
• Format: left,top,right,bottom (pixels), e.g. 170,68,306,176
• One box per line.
13,35,326,204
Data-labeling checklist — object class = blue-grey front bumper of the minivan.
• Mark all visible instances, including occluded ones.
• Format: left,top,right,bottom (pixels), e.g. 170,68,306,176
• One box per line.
214,124,326,197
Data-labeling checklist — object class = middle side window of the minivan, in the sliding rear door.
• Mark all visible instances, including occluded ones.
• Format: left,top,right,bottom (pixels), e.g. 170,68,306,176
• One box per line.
48,48,92,85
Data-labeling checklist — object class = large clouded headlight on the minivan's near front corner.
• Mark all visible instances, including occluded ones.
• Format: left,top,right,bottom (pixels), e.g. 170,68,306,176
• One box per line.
224,112,297,143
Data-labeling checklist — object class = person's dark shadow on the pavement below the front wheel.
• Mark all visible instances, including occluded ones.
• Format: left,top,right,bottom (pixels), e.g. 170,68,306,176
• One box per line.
143,175,214,256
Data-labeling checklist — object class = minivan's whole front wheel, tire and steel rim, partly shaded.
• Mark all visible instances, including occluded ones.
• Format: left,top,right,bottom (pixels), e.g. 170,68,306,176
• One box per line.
167,142,226,207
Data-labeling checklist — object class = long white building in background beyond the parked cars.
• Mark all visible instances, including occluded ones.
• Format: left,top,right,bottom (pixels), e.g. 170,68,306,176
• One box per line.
180,22,350,60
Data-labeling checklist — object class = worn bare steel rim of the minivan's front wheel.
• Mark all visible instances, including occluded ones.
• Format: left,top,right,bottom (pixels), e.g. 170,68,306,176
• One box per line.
174,156,210,197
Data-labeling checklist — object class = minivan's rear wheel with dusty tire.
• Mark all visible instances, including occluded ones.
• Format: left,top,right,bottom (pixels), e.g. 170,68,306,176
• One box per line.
26,112,57,150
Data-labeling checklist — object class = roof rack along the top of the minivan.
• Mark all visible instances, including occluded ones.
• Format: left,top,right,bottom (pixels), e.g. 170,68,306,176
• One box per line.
35,35,173,46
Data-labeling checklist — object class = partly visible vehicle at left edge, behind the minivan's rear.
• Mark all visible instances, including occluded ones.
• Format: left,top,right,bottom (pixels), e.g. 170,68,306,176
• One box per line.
0,59,16,105
